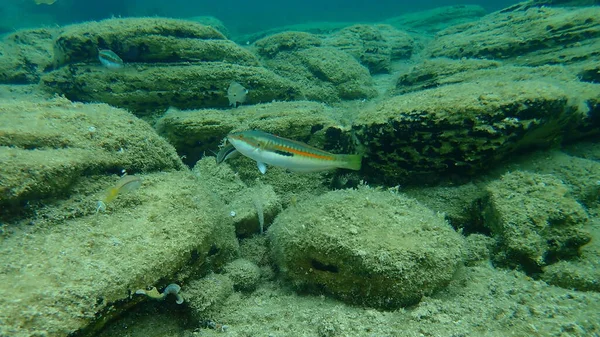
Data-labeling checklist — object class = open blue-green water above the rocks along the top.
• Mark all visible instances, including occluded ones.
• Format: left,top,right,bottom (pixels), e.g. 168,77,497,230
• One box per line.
0,0,518,34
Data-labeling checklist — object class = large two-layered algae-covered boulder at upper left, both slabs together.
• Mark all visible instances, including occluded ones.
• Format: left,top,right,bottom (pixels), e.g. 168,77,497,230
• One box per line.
42,18,299,115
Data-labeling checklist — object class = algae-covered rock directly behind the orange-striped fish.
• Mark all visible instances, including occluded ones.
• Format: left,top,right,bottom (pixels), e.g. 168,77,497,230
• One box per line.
156,101,358,165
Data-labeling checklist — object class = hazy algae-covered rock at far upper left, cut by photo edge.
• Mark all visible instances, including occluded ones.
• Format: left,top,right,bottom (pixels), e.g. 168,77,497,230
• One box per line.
0,28,57,84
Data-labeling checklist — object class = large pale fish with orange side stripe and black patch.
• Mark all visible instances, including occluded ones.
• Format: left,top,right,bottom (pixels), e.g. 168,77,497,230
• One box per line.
227,130,362,174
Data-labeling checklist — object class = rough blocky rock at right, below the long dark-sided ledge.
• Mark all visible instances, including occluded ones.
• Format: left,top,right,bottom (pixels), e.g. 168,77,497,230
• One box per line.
483,171,590,272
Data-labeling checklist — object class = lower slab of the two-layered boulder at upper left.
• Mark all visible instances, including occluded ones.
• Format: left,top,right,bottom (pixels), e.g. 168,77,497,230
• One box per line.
42,62,298,114
